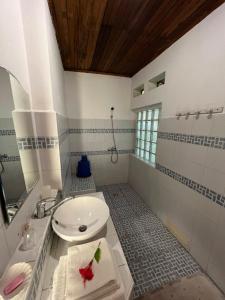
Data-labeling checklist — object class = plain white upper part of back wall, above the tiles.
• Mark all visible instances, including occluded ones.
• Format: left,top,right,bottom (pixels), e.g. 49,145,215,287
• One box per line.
65,72,134,120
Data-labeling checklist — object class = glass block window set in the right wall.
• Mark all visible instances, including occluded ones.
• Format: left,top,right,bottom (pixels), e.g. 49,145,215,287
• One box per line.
135,107,160,165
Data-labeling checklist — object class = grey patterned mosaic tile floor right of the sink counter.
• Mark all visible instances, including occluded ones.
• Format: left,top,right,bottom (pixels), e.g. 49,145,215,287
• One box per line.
98,184,200,298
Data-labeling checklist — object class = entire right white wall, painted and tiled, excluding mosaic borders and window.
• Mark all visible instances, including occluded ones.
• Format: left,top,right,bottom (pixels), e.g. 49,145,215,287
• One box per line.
129,4,225,291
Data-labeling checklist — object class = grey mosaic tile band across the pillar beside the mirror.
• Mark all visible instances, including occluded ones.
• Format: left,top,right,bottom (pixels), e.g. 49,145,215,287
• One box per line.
17,136,59,150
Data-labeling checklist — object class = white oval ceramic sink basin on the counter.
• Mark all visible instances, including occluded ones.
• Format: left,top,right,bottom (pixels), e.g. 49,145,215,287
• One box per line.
52,196,109,242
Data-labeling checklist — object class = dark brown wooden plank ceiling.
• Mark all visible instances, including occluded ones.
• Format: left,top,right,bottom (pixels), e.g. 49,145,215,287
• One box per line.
48,0,225,77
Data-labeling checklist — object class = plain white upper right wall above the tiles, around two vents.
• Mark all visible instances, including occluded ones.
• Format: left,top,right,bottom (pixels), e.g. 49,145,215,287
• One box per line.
131,4,225,117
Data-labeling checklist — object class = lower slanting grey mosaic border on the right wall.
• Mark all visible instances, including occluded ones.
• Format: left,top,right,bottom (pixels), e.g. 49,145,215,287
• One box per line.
156,163,225,207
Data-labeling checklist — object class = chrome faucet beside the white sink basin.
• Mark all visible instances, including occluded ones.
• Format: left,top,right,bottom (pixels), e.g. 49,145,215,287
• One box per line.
36,197,73,219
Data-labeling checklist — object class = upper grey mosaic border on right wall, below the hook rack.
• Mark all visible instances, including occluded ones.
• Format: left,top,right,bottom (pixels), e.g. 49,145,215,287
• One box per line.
158,132,225,150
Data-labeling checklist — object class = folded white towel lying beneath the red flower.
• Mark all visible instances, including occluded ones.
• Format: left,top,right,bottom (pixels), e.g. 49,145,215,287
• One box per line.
65,238,120,300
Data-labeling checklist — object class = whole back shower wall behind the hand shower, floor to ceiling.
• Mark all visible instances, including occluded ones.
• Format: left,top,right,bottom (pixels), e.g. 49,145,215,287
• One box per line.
65,72,135,185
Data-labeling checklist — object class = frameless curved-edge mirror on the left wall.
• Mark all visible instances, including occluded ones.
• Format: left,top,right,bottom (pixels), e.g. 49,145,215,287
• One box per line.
0,67,39,223
